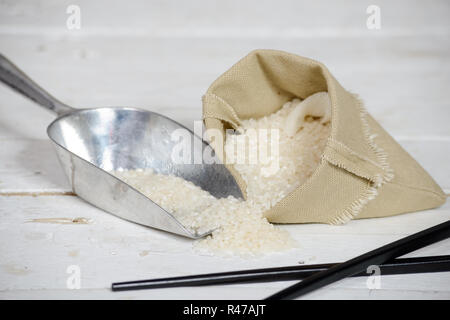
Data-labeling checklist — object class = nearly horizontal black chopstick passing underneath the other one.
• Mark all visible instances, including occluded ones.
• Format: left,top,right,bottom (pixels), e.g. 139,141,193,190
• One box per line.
111,255,450,291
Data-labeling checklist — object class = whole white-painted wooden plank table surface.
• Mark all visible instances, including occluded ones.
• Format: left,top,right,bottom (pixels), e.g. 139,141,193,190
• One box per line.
0,0,450,299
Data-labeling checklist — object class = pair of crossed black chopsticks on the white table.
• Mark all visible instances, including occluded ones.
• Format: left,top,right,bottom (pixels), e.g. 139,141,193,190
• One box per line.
111,221,450,299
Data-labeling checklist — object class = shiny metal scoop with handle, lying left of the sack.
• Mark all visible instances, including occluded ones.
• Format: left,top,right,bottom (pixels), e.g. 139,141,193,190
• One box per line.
0,54,242,239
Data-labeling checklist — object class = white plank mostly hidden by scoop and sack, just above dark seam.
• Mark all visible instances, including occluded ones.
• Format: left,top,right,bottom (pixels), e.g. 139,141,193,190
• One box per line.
0,138,450,195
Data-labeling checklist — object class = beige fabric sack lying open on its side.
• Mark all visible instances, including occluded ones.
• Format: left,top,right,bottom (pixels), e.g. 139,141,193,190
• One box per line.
203,50,446,224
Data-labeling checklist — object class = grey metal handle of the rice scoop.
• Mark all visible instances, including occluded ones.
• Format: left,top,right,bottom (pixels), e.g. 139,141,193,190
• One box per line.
0,54,76,116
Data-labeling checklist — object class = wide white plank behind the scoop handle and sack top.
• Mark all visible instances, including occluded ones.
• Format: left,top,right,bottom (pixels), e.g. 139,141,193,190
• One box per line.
0,35,450,139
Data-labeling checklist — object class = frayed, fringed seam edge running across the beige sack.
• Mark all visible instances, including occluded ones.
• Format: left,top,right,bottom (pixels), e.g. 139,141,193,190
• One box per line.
330,94,394,224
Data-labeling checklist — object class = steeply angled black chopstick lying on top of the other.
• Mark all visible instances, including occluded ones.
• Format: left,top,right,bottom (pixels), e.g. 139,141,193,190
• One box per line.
267,221,450,300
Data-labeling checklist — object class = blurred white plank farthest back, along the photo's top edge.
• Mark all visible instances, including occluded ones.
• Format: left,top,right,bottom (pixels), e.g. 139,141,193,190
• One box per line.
0,0,449,37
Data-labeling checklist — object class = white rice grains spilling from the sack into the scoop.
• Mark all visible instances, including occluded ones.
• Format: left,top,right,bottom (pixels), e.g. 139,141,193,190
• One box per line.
113,103,330,256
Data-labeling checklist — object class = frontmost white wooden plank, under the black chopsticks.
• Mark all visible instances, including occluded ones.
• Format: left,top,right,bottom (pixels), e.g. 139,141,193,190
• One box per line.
0,196,450,298
